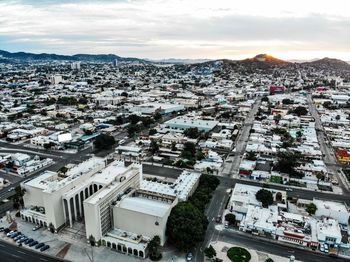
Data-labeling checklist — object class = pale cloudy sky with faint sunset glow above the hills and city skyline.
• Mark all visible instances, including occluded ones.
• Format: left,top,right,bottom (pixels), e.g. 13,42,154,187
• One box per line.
0,0,350,61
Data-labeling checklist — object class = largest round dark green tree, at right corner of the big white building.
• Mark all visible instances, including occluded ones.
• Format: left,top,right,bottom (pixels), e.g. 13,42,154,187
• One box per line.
166,201,208,251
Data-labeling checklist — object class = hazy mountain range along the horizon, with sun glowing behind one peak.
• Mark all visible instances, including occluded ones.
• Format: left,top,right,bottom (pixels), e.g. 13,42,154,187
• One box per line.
0,50,350,71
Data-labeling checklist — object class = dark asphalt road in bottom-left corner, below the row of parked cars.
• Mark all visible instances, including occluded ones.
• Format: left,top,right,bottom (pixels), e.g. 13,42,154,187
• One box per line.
0,240,65,262
